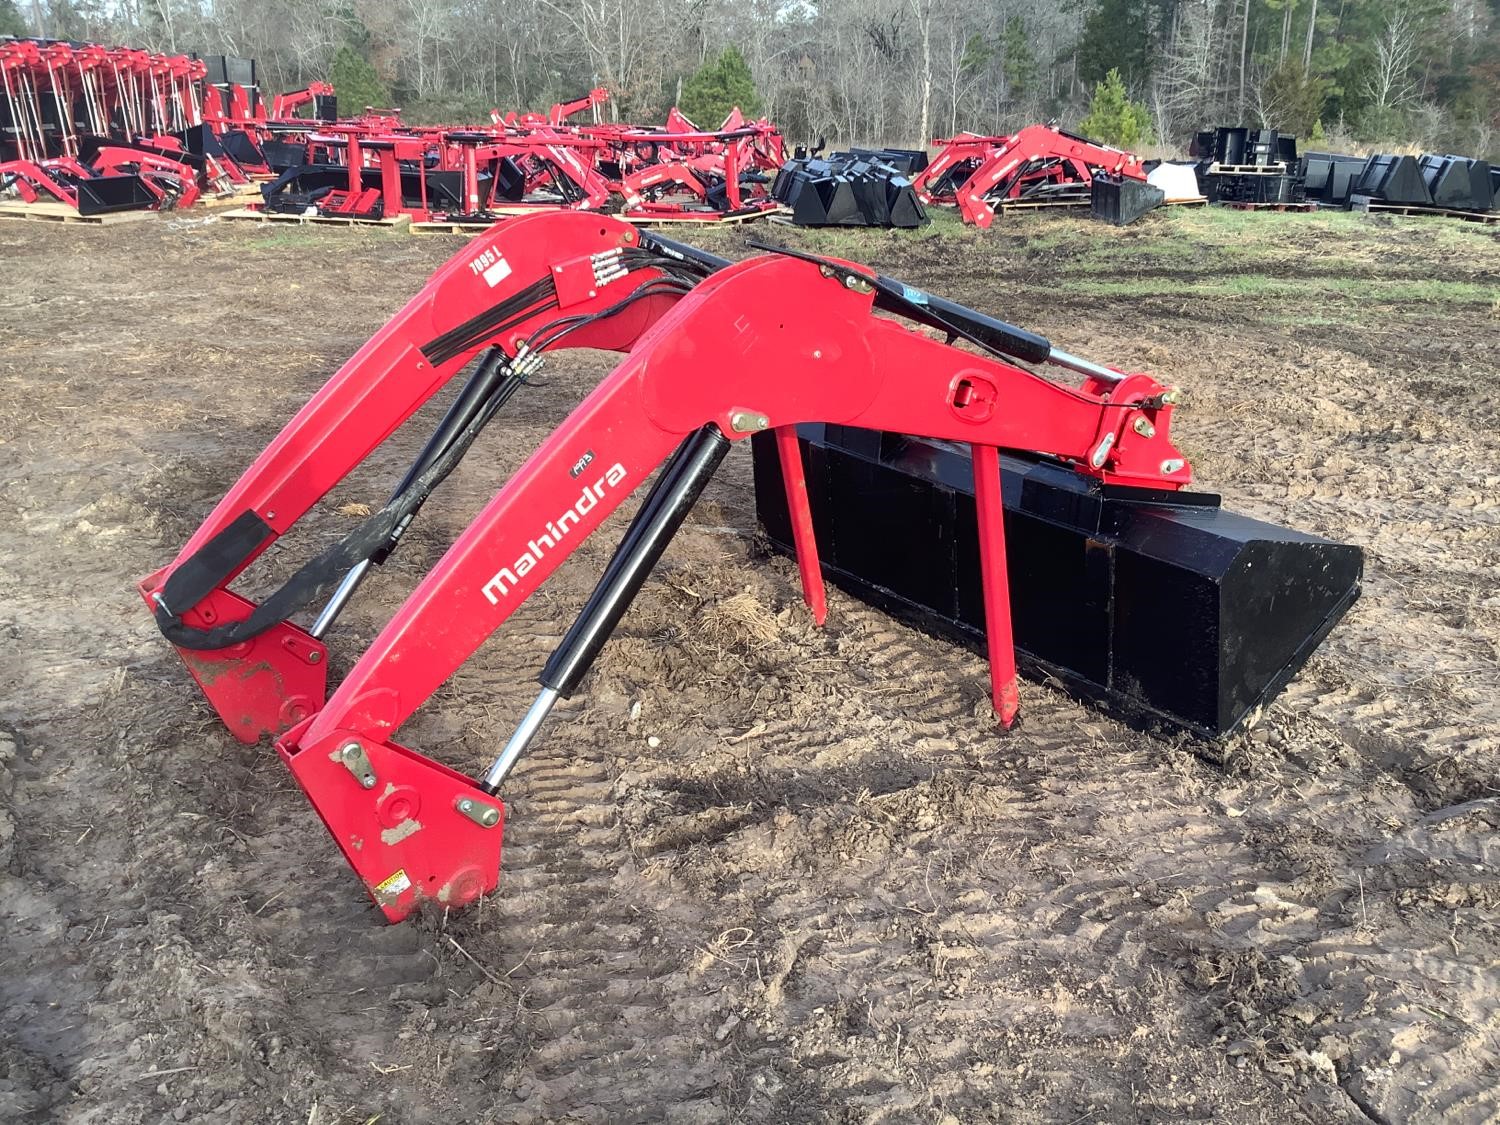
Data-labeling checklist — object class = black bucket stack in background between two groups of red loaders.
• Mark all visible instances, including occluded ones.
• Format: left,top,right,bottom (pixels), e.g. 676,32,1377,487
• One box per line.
771,149,927,230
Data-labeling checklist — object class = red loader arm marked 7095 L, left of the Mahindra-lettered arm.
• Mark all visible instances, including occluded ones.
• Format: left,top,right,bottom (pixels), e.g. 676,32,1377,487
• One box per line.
141,213,680,743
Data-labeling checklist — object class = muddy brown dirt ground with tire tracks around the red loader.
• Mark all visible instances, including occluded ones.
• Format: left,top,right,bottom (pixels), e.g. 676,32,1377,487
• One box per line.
0,205,1500,1125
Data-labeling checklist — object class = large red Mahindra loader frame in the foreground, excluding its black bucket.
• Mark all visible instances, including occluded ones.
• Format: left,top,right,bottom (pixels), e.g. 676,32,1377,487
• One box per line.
140,213,1190,921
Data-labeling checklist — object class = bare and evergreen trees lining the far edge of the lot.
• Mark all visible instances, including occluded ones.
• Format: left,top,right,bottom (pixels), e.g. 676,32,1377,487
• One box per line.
0,0,1500,156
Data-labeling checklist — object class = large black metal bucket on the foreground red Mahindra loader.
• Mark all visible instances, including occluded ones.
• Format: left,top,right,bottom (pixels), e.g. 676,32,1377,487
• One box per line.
753,423,1364,740
